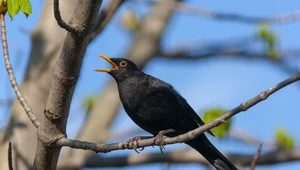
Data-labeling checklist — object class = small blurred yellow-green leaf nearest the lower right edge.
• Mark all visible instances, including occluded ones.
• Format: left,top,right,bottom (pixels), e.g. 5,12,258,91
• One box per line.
276,129,294,150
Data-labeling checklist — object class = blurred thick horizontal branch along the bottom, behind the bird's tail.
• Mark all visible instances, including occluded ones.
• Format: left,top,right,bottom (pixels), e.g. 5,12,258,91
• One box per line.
58,149,300,169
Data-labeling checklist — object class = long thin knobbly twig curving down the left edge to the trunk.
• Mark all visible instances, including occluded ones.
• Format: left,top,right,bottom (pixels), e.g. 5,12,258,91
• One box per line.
0,14,40,128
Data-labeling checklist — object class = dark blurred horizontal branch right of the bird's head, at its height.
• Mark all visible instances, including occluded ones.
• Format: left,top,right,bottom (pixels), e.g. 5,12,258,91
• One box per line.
157,42,300,74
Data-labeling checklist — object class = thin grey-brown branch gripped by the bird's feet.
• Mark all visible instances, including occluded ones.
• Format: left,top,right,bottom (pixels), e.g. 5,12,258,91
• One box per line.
56,73,300,152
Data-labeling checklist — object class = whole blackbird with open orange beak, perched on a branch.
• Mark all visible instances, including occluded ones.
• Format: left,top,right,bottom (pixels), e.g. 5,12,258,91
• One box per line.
95,55,237,170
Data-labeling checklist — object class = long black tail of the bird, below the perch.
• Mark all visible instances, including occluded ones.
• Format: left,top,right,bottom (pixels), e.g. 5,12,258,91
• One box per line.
186,135,238,170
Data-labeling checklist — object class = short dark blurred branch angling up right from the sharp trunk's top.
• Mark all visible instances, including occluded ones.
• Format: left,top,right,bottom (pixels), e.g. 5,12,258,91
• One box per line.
89,0,124,41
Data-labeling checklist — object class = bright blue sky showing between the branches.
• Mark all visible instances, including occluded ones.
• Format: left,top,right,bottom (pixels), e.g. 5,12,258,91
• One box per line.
0,0,300,170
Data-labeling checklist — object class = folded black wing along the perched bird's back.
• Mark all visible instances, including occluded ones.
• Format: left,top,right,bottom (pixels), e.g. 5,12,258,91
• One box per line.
150,79,215,136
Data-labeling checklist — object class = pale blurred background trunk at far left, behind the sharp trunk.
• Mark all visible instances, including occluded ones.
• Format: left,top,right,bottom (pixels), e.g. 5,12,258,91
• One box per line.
0,0,77,170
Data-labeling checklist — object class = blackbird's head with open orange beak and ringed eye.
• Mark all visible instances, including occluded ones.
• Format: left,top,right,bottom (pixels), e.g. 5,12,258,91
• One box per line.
95,54,140,82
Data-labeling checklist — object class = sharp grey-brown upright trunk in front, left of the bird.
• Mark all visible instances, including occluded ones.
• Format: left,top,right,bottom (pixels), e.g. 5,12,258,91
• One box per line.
34,0,102,170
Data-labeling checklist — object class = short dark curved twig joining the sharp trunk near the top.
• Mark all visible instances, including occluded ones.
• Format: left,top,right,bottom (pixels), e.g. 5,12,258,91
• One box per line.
53,0,80,33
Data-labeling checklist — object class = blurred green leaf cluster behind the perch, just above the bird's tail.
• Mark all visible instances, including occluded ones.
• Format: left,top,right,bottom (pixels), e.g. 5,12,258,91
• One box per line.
203,107,231,139
